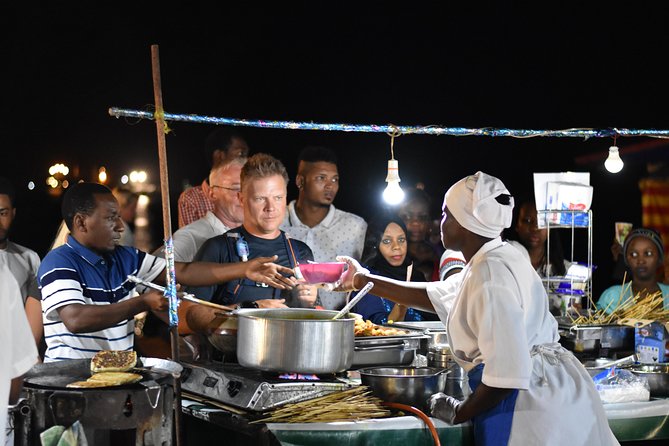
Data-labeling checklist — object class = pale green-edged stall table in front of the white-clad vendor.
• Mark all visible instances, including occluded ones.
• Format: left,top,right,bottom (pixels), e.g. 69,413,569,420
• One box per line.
182,399,669,446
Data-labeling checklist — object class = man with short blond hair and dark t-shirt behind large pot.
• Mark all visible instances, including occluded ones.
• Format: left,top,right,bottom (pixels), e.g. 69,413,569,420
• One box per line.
188,153,317,308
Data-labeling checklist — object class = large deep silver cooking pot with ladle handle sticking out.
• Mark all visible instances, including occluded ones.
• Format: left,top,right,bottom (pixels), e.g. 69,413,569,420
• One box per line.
237,308,355,374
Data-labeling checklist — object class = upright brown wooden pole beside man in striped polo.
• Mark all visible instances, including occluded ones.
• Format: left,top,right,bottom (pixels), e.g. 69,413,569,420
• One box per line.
151,45,181,446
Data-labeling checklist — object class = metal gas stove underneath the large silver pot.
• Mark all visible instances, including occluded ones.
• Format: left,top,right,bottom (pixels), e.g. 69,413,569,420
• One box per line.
181,361,357,412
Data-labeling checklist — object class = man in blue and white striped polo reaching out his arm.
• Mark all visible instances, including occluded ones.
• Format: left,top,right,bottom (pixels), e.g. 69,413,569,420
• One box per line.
38,183,296,362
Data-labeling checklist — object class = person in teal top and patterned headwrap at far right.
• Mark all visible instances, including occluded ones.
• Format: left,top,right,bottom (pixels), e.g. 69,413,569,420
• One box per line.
597,228,669,314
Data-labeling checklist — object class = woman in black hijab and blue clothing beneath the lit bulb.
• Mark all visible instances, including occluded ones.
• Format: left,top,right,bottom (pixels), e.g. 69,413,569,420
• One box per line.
351,215,425,324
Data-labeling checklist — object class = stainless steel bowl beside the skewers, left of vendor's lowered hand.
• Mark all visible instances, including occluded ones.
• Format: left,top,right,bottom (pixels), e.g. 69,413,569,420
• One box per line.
359,367,448,410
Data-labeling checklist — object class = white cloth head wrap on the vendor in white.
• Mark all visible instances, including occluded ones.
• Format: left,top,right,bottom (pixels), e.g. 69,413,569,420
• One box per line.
446,171,513,238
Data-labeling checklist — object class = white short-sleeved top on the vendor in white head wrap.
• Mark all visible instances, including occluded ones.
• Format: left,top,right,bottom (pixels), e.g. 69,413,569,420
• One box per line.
440,237,559,389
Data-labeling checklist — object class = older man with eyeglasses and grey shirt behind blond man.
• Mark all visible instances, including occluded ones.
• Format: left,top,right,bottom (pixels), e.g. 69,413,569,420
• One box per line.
156,156,247,262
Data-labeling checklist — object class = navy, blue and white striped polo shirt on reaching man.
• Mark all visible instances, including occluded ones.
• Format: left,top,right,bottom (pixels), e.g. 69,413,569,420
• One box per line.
38,236,165,362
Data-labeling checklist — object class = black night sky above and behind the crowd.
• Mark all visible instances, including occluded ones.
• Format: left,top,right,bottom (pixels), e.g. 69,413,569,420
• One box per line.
0,1,669,293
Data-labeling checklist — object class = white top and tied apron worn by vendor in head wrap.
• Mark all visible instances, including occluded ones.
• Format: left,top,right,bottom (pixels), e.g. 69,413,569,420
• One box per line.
438,242,618,446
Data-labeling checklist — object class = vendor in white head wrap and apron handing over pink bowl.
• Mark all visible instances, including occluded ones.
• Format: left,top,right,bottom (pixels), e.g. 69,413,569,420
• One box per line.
340,172,618,446
